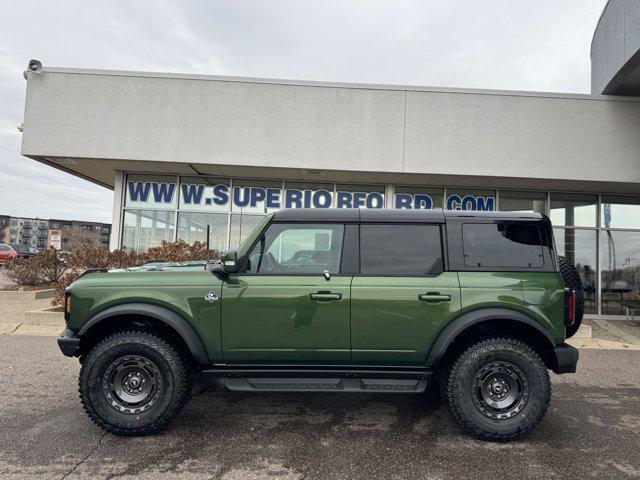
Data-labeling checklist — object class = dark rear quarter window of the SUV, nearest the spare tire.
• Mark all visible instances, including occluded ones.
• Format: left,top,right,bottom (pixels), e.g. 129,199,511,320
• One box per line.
462,222,544,268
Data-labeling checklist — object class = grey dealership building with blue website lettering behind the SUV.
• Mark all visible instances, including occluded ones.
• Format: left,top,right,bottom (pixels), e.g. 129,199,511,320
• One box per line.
17,0,640,316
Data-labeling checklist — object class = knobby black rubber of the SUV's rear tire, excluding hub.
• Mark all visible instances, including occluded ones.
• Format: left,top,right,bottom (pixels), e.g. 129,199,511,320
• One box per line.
447,337,551,442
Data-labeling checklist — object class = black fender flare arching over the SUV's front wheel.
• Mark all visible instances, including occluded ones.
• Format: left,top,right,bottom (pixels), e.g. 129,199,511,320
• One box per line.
78,303,209,365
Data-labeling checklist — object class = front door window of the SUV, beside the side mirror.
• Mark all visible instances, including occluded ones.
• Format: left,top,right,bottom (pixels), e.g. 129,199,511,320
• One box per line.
247,223,344,275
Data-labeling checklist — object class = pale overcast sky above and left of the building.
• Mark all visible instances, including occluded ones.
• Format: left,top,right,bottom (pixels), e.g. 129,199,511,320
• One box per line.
0,0,606,222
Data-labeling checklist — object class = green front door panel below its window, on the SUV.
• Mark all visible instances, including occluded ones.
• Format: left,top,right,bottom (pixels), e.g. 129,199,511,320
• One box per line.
222,275,351,365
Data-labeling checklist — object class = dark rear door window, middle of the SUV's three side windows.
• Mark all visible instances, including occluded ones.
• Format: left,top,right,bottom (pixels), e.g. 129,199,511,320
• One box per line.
360,225,443,277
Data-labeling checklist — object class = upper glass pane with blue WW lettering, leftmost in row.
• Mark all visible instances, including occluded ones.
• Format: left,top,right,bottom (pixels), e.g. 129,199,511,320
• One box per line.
125,173,178,209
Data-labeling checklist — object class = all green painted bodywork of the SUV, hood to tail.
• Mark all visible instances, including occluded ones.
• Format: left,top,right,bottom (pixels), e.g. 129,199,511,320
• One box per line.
67,216,565,368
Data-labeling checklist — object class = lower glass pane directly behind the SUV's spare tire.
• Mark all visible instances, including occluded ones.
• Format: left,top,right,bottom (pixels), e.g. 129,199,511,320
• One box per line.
553,228,598,313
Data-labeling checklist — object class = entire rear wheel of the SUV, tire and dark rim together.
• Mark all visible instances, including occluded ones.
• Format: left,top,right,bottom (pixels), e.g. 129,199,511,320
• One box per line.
446,338,551,441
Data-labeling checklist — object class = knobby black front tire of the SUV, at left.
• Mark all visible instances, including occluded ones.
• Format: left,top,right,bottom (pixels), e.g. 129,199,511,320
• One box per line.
78,330,193,436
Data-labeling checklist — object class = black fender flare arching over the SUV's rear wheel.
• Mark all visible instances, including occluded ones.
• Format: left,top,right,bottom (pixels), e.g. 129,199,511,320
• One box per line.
426,308,556,367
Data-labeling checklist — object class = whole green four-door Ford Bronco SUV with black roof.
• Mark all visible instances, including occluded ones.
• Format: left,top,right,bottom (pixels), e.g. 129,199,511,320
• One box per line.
58,209,583,441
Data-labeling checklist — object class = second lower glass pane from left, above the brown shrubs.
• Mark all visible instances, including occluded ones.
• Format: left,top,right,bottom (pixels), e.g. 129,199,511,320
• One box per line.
178,212,229,252
